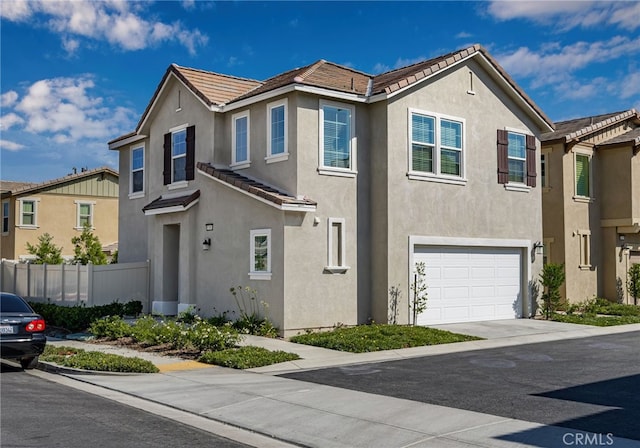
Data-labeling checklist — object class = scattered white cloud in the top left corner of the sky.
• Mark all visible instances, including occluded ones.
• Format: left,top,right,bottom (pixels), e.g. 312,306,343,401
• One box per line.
0,0,209,54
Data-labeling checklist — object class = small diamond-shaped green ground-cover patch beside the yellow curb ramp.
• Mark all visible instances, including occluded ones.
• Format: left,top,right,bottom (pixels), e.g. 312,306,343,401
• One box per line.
199,346,300,369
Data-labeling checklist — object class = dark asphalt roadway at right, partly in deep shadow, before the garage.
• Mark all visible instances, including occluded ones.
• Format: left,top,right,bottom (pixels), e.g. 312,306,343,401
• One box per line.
281,332,640,440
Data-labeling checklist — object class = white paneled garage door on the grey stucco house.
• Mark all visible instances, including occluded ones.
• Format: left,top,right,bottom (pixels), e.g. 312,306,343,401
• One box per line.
414,247,522,325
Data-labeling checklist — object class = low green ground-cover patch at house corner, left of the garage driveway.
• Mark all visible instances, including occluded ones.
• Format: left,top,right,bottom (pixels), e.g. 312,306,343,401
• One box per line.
290,324,482,353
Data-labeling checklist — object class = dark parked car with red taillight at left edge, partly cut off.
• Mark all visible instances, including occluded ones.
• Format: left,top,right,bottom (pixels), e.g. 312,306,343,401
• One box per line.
0,292,47,369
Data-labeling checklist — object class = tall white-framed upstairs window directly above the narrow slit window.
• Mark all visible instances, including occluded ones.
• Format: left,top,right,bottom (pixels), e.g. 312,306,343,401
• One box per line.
318,100,357,177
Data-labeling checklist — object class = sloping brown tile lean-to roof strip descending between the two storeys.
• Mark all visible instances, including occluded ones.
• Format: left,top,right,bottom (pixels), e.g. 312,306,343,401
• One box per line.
197,162,317,208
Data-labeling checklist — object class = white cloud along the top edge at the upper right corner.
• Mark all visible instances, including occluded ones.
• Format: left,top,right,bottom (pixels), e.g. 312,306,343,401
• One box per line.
487,0,640,31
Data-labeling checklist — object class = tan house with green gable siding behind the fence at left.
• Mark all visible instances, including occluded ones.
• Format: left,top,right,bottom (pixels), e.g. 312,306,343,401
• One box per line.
0,168,118,260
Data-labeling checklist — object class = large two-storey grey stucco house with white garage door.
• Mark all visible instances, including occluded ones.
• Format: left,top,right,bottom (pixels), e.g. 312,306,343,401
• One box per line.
109,45,553,335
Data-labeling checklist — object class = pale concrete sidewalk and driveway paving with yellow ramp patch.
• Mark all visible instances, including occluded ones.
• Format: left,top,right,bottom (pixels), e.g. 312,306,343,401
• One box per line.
38,320,640,448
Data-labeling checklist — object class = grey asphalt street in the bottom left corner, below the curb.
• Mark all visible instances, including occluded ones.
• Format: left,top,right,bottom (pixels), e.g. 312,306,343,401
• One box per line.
0,363,255,448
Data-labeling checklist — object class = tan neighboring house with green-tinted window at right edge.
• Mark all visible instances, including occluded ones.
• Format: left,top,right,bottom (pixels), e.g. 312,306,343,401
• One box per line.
541,109,640,302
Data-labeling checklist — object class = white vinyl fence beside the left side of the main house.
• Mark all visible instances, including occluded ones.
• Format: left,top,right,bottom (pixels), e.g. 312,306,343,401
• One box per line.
0,260,150,312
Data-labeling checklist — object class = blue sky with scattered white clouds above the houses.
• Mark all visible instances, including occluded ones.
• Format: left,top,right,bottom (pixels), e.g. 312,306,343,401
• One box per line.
0,0,640,182
